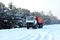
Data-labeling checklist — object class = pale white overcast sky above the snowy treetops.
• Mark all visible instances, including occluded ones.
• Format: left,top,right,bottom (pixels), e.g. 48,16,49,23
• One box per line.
0,0,60,19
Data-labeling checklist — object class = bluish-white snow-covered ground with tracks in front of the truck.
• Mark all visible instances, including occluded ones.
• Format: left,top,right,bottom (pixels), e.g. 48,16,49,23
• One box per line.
0,24,60,40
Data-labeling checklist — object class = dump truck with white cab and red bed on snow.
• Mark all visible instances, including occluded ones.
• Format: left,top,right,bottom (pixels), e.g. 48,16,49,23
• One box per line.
26,16,43,29
